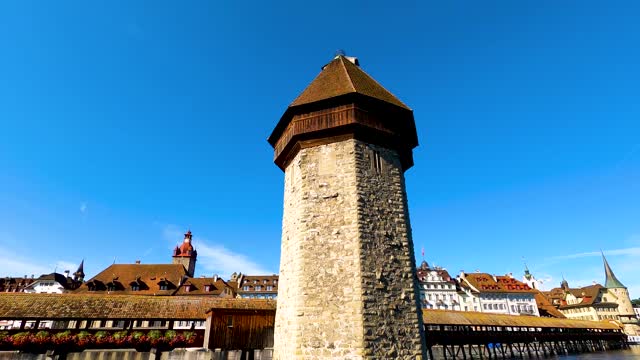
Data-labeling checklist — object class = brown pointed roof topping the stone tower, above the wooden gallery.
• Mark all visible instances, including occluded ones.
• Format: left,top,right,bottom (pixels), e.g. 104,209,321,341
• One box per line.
289,55,411,110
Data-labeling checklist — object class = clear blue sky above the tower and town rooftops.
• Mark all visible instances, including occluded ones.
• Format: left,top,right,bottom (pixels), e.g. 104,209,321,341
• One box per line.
0,1,640,297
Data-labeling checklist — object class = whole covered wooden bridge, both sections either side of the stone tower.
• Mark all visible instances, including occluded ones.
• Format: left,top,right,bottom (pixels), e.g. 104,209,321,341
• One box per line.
0,293,628,360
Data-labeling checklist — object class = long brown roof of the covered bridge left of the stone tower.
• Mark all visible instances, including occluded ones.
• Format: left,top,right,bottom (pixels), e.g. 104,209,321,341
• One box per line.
0,293,276,320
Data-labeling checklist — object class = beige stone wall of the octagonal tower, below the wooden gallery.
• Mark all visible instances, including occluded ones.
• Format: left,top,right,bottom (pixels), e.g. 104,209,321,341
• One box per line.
274,139,424,360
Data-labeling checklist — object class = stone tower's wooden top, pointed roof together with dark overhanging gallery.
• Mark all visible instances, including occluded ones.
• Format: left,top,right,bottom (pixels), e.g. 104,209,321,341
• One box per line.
267,55,418,171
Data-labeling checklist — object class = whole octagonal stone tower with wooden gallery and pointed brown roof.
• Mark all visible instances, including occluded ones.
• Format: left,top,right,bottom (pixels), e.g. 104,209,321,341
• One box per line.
269,55,426,360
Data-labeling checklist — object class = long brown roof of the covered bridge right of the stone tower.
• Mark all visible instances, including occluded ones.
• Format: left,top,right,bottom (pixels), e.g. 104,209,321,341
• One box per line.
422,309,620,330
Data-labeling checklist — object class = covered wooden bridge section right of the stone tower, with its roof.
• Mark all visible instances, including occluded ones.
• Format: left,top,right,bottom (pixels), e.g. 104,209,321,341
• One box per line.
423,310,628,360
